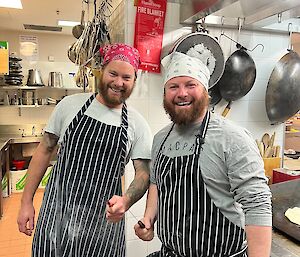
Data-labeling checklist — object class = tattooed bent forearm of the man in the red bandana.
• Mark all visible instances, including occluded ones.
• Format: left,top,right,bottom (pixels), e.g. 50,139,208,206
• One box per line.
126,159,150,207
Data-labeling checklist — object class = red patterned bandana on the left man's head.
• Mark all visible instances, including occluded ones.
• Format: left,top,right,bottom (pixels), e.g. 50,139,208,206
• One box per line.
100,43,140,71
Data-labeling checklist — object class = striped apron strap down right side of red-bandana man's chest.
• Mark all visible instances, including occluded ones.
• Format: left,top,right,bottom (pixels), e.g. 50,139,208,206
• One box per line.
120,102,128,175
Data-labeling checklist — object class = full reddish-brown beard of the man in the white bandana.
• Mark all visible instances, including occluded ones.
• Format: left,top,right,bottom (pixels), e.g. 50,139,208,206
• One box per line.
163,91,210,125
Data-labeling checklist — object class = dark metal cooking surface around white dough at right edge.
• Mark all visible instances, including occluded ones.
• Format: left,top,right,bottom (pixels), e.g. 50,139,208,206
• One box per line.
270,179,300,241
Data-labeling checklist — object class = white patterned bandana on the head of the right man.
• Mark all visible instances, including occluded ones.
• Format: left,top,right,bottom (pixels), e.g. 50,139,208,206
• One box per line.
161,52,210,90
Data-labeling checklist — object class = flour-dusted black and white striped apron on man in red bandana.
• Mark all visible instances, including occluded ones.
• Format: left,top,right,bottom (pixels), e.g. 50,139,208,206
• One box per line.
32,94,128,257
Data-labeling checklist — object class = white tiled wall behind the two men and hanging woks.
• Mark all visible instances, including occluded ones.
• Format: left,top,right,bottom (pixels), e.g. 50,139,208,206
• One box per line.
125,1,288,254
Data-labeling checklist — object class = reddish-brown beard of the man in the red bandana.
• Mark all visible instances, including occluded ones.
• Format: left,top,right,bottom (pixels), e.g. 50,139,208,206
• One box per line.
98,79,134,106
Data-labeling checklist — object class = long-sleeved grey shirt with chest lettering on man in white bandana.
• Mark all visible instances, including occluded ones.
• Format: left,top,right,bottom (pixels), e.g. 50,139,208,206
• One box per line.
150,114,272,227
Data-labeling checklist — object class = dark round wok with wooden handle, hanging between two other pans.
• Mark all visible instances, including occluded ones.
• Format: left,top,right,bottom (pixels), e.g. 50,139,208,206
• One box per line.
218,44,256,116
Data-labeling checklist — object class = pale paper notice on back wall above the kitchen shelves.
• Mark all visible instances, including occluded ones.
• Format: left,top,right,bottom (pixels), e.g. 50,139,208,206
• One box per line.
19,35,39,61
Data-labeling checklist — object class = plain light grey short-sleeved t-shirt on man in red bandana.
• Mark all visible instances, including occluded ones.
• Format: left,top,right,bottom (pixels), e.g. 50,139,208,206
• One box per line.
45,93,152,163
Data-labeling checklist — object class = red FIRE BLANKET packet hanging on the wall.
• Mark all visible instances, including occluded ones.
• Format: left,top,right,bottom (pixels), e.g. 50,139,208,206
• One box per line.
134,0,167,73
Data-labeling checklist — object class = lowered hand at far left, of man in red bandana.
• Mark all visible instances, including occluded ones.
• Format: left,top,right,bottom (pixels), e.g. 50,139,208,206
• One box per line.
17,203,35,236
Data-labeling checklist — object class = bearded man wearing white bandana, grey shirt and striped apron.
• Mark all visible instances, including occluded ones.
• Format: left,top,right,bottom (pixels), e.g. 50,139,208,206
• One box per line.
135,52,272,257
